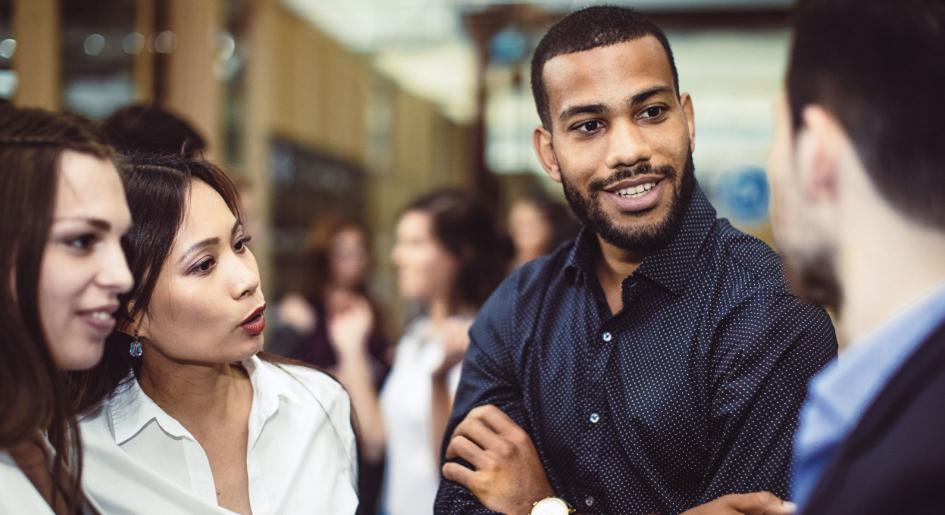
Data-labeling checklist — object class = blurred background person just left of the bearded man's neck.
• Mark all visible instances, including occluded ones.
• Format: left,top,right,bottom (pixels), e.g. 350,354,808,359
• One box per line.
508,195,581,267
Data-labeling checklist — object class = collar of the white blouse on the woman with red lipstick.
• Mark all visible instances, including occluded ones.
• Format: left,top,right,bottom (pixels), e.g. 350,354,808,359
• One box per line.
108,356,303,445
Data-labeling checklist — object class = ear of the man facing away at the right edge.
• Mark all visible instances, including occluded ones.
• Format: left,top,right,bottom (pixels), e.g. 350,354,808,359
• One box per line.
795,105,850,200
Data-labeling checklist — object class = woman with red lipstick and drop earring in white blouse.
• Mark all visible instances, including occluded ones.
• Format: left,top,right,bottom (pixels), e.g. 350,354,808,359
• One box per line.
70,156,358,515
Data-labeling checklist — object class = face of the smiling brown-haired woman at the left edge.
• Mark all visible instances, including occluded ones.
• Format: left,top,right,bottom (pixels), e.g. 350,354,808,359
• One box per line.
39,150,133,370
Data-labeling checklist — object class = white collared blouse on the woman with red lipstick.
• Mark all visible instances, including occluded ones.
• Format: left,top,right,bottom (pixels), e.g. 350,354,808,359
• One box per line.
80,356,358,515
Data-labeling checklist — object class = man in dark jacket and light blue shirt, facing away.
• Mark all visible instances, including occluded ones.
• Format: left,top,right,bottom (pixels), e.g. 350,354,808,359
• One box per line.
769,0,945,515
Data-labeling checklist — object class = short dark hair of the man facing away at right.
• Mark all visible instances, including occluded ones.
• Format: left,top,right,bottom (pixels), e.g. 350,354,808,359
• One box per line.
787,0,945,229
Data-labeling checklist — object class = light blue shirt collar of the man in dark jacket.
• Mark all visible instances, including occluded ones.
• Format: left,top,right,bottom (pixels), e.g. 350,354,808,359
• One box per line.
792,285,945,510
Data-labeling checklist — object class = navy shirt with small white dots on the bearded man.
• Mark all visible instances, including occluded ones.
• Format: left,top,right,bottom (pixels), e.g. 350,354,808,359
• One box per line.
435,188,837,515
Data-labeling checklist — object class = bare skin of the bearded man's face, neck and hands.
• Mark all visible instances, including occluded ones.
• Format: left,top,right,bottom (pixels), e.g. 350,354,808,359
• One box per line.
443,36,790,515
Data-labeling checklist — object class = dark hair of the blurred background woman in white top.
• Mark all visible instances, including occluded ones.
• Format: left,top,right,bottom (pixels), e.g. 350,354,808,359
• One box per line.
403,189,512,308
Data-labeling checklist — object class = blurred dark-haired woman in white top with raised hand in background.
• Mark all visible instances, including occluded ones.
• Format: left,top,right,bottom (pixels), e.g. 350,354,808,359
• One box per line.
331,190,511,515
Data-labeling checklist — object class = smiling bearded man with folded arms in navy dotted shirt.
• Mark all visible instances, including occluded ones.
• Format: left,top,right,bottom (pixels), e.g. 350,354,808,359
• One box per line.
435,7,837,515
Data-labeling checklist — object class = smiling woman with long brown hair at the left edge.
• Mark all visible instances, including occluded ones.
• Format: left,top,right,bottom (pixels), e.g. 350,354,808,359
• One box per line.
0,106,132,515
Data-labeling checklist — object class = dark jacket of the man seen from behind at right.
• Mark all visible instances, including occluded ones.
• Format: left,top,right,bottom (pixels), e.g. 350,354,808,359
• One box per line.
803,325,945,515
